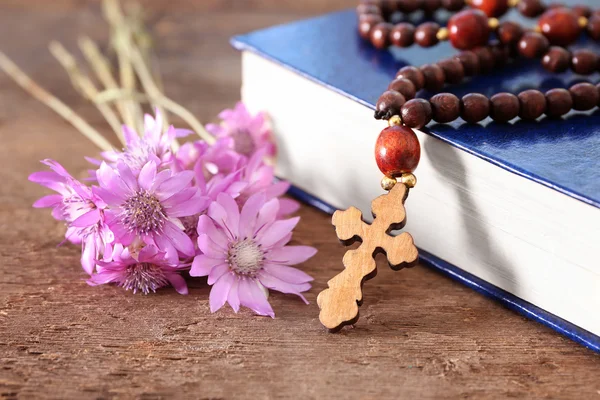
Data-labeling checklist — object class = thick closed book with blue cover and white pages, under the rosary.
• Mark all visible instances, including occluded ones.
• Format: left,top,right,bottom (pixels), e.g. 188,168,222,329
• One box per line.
232,0,600,352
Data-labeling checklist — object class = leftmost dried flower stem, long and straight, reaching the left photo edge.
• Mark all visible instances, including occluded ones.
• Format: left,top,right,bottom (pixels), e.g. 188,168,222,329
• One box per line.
0,51,113,151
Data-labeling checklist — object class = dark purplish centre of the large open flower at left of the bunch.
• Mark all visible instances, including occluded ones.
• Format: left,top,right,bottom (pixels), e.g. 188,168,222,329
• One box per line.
122,190,167,234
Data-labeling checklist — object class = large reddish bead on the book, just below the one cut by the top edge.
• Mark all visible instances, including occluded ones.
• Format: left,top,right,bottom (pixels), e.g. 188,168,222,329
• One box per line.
448,10,490,50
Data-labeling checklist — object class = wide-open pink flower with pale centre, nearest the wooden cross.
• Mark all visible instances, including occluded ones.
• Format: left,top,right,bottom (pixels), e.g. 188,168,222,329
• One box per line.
190,193,316,318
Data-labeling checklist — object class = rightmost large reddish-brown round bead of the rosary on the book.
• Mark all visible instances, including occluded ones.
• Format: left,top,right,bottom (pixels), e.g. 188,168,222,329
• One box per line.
538,7,581,46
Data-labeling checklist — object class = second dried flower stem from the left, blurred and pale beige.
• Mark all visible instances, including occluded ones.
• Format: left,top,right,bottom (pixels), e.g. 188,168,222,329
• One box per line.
49,41,125,144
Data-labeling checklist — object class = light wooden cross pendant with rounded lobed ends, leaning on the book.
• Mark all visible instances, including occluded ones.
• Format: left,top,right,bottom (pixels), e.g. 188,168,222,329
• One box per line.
317,183,419,332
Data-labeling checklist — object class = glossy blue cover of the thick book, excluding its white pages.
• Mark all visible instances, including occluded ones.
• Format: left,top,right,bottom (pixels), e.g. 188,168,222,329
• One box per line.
232,3,600,351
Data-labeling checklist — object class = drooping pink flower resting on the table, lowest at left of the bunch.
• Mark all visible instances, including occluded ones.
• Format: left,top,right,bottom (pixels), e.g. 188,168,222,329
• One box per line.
87,244,188,294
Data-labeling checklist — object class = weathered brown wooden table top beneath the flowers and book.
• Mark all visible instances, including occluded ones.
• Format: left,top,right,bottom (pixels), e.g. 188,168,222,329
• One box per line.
0,0,600,399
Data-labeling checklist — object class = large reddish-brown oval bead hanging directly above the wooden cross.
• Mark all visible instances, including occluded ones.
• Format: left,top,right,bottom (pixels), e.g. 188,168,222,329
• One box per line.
375,125,421,178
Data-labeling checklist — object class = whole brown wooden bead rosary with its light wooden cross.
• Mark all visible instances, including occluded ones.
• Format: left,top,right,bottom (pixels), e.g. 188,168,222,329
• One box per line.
317,0,600,332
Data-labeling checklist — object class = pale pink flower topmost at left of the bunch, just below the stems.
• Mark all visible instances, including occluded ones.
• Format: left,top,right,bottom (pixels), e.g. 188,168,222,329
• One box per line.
102,110,192,174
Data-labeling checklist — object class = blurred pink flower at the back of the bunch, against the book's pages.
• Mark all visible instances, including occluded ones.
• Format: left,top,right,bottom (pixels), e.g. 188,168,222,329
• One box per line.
206,102,276,157
